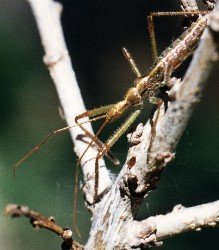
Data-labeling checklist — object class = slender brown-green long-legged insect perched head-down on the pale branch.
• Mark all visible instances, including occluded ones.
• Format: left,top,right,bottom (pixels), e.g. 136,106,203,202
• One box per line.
14,6,208,238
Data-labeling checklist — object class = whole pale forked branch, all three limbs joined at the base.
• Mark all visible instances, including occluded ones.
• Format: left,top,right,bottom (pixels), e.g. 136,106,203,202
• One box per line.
5,0,219,249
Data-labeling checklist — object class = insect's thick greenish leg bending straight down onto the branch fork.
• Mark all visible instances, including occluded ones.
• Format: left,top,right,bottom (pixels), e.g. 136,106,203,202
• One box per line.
94,110,141,202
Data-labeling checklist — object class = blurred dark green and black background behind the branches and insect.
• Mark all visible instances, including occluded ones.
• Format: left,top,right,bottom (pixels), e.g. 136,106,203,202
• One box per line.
0,0,219,250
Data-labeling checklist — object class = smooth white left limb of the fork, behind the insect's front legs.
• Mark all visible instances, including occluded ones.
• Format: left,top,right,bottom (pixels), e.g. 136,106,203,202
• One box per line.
28,0,111,203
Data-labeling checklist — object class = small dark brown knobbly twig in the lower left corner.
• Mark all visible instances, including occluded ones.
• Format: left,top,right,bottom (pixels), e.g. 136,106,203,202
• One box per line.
4,204,83,250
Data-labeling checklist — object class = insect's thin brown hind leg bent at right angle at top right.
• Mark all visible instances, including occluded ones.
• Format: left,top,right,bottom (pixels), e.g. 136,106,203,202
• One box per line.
147,10,207,61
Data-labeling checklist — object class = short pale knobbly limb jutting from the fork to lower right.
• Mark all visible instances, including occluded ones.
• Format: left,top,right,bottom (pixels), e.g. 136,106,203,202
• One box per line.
127,201,219,248
